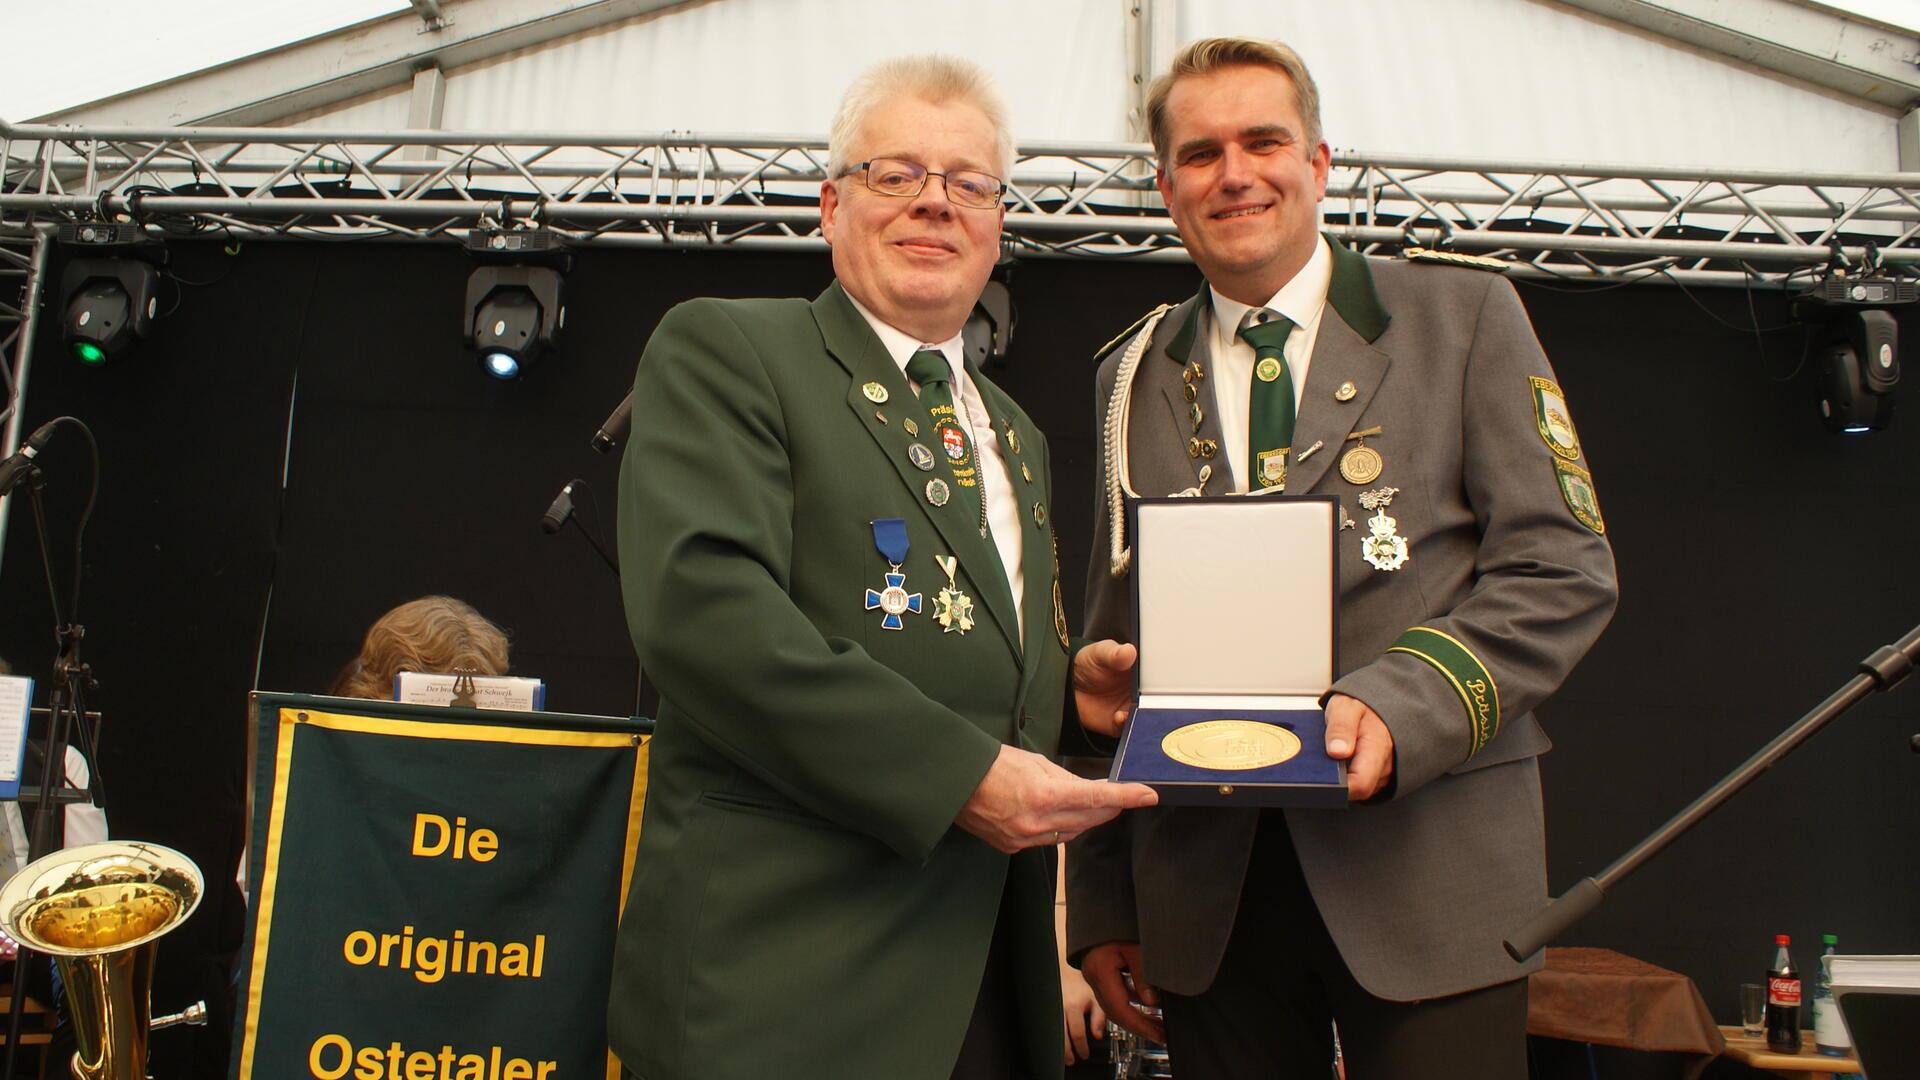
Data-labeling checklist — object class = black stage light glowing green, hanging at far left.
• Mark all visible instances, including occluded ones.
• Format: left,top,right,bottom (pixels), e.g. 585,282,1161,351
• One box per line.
58,223,165,367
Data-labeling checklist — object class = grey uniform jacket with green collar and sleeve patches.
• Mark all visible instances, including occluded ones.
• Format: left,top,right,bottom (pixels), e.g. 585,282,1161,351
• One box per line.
1068,244,1617,1001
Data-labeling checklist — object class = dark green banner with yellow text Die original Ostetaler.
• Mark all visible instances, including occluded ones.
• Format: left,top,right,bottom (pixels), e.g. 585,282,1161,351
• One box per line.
232,694,647,1080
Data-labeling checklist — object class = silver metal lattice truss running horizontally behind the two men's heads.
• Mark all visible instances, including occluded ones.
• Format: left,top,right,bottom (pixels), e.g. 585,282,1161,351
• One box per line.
0,121,1920,284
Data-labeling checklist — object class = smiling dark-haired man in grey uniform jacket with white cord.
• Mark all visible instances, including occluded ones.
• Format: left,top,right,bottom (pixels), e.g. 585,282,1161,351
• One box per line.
1068,38,1615,1080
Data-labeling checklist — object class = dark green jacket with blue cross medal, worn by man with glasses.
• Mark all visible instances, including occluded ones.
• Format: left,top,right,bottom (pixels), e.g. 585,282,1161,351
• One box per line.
607,284,1068,1080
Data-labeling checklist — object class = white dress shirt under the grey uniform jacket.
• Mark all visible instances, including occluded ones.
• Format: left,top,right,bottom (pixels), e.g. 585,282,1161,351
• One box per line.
1206,236,1332,492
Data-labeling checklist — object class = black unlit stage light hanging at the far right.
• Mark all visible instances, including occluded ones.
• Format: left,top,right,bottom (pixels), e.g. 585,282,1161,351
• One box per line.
1793,273,1920,434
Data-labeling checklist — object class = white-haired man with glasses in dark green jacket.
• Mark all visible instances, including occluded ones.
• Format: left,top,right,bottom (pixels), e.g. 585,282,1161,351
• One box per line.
609,58,1154,1080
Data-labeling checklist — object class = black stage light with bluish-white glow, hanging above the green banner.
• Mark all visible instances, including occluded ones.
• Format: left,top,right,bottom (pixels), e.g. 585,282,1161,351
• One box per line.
467,229,566,379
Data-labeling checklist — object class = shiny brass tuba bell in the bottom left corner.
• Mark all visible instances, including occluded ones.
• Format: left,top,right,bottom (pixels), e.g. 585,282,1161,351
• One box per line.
0,842,202,1080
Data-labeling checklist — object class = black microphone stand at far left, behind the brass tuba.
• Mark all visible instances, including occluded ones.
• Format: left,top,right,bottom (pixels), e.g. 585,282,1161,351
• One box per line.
0,417,100,1080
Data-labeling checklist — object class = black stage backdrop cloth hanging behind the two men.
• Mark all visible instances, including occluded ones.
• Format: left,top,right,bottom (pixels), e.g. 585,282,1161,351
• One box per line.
0,242,1920,1080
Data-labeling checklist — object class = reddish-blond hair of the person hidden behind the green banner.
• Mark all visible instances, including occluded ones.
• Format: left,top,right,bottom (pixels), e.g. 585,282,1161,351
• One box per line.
332,596,507,700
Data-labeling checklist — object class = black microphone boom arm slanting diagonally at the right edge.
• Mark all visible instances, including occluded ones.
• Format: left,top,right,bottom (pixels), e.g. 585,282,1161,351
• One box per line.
1501,626,1920,961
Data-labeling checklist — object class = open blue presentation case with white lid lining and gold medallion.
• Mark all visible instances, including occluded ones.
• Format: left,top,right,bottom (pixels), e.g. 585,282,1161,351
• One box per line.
1108,496,1346,809
